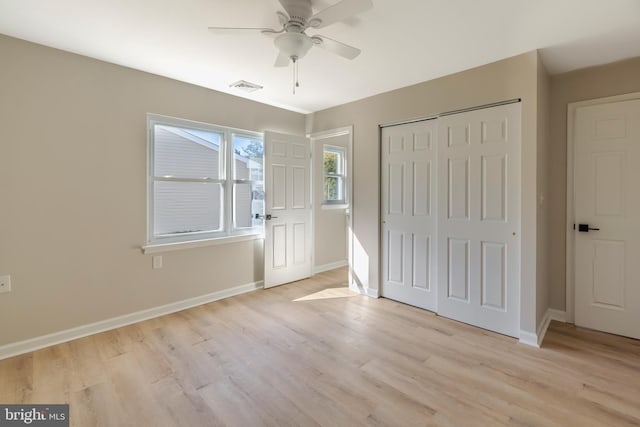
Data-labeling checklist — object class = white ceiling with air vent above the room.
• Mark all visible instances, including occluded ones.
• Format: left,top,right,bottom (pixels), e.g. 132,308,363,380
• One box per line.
0,0,640,113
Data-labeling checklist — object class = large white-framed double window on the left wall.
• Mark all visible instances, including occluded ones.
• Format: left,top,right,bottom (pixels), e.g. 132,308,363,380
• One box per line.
148,115,264,244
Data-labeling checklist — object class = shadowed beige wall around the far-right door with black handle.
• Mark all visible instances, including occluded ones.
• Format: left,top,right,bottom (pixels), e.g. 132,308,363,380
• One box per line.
548,57,640,310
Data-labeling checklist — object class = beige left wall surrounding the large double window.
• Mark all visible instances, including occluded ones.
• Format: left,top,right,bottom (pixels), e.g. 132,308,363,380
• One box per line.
0,36,306,346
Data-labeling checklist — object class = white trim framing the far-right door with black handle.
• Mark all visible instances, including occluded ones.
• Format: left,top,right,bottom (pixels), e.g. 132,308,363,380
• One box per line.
565,92,640,323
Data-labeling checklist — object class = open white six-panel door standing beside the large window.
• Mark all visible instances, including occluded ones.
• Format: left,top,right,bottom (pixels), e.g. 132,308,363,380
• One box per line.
264,132,312,288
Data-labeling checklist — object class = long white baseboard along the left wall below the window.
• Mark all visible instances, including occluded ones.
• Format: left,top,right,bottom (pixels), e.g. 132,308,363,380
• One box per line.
0,281,264,360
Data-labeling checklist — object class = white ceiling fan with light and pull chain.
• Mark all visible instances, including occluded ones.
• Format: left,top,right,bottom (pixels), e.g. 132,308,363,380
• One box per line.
209,0,373,93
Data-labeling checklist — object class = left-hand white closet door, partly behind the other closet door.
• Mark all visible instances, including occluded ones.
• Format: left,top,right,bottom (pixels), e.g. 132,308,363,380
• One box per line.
381,120,436,311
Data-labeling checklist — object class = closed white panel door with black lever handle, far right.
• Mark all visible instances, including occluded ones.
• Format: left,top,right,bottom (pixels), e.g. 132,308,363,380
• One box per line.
574,100,640,339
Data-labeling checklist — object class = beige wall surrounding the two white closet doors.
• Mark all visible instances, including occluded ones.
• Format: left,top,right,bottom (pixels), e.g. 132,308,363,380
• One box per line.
311,52,538,332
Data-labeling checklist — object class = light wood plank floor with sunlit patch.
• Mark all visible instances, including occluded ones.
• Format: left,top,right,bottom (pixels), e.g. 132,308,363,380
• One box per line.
0,269,640,427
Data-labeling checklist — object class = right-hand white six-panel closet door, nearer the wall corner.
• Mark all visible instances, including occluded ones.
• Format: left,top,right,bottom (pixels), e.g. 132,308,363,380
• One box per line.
438,103,521,337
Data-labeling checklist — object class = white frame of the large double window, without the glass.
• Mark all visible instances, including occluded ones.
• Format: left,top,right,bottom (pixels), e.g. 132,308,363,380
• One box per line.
145,113,264,249
